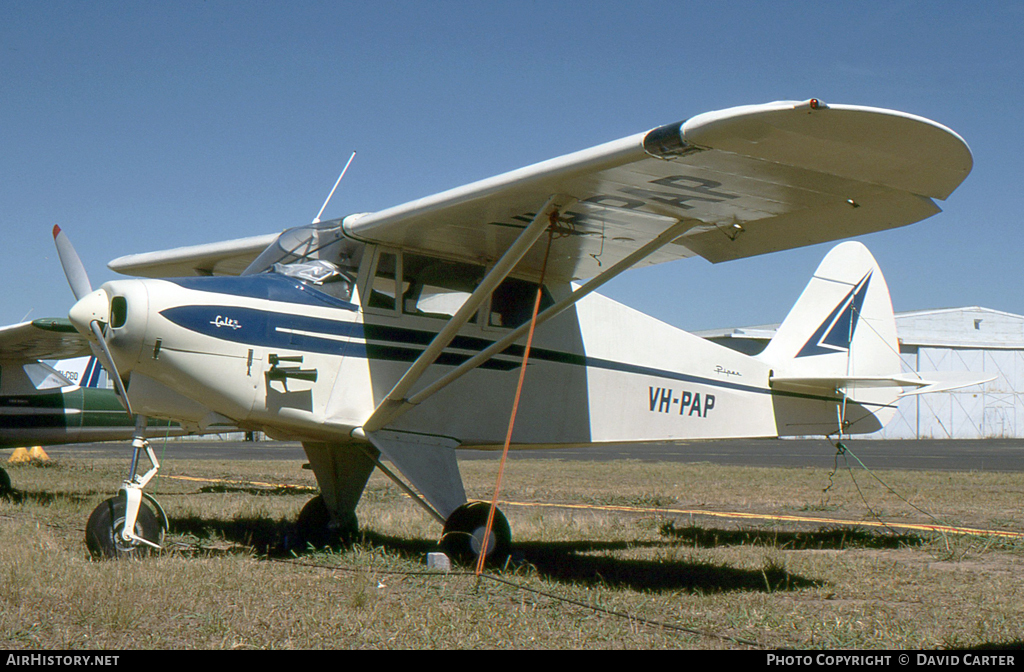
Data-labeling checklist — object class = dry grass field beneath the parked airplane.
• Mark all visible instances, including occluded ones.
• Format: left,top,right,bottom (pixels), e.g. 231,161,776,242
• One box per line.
0,451,1024,649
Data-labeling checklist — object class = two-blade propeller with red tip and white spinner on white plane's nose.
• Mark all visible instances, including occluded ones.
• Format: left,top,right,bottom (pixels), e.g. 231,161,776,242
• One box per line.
53,224,134,415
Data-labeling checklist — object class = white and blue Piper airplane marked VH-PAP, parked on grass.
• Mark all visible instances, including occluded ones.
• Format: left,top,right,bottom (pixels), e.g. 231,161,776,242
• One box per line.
46,99,978,560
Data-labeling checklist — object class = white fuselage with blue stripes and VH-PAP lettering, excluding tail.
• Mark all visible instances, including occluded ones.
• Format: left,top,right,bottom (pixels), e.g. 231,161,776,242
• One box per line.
94,241,778,446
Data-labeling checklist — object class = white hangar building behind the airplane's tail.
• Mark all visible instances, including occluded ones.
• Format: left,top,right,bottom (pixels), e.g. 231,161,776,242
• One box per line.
697,306,1024,438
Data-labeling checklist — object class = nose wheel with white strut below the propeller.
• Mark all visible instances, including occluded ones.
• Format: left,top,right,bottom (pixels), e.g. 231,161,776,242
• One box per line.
85,416,168,559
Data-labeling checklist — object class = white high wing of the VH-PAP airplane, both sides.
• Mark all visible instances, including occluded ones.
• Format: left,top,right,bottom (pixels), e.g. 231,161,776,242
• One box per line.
111,99,973,280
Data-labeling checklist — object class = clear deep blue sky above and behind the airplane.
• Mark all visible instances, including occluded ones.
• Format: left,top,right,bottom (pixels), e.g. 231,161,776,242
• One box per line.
0,0,1024,330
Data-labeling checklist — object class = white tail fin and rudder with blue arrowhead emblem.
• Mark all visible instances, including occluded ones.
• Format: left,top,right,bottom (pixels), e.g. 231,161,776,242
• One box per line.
758,242,900,435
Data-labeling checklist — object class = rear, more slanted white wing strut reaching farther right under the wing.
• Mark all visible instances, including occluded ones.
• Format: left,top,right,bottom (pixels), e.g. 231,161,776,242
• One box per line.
364,219,701,428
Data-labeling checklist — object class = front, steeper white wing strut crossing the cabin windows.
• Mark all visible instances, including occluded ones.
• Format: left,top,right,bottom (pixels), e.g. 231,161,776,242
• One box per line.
362,194,575,432
